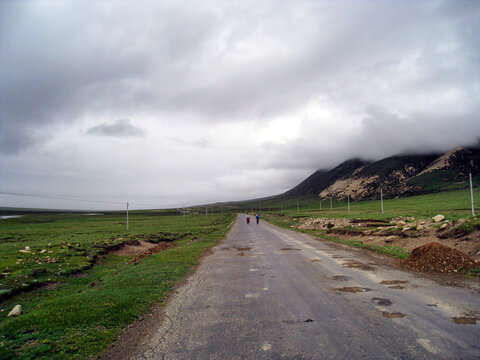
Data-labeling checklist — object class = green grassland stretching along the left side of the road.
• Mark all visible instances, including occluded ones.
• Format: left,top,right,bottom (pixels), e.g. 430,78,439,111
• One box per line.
0,211,235,359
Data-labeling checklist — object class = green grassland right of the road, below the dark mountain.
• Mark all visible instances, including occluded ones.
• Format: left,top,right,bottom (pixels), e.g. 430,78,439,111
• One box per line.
253,188,480,259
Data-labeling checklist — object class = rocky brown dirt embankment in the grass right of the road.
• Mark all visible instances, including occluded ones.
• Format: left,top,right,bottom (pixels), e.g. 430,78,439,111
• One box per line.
299,216,480,260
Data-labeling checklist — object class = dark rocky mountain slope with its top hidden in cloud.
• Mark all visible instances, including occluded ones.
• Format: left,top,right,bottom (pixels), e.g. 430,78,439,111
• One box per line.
277,145,480,200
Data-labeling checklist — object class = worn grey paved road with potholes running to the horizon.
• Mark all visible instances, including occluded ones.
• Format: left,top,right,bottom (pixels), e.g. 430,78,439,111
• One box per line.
133,215,480,359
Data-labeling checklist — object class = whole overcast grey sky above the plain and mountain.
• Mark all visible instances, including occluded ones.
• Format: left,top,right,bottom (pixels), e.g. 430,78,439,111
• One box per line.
0,0,480,210
